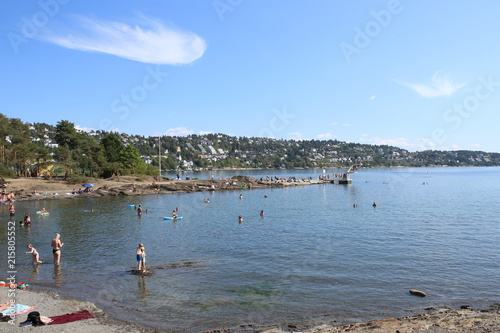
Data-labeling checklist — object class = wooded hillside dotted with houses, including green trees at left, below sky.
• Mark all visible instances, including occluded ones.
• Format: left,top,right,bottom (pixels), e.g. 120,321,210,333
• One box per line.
0,114,500,177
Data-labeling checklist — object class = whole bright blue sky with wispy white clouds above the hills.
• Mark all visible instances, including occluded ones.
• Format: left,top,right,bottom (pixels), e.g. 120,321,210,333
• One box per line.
0,0,500,152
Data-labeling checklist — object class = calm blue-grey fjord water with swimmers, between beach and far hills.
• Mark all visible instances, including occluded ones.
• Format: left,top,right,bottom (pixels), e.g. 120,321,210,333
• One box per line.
0,168,500,332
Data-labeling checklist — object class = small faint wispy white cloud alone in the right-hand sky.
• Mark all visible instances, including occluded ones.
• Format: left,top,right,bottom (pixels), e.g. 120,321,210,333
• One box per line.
394,71,466,98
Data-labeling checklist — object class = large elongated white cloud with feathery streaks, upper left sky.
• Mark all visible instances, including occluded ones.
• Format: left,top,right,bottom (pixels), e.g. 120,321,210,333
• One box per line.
39,16,207,65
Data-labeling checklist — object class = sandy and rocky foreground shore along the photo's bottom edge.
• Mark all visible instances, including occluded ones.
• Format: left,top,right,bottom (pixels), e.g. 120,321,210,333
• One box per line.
0,288,500,333
